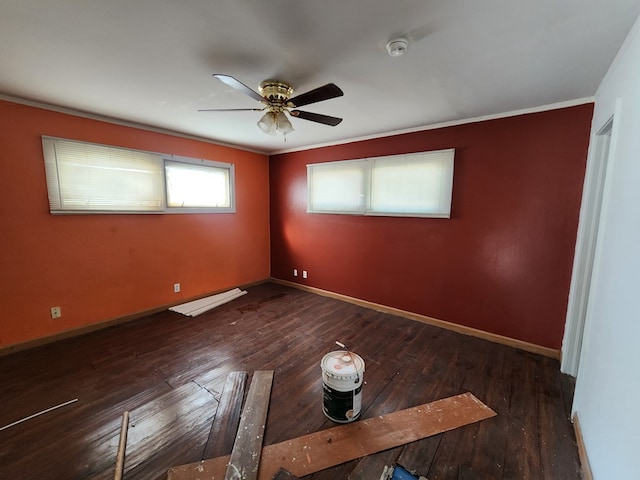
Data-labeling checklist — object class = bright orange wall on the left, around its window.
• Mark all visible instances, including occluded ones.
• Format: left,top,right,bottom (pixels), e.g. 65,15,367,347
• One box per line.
0,101,269,347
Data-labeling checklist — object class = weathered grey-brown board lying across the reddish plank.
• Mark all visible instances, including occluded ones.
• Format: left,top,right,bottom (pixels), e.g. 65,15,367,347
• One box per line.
224,370,273,480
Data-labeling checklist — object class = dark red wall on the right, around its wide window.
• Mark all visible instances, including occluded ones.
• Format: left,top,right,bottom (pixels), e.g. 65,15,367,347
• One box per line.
270,104,593,349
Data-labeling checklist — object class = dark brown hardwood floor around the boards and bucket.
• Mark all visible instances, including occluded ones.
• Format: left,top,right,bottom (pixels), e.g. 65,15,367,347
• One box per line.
0,283,582,480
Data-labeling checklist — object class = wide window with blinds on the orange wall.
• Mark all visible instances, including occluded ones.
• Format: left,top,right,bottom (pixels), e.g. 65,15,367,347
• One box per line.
42,137,235,214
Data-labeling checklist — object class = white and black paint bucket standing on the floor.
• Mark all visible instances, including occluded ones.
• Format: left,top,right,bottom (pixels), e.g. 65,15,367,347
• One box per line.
320,350,364,423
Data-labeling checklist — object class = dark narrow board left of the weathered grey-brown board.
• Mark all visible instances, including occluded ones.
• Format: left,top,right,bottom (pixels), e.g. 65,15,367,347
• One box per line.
202,371,247,460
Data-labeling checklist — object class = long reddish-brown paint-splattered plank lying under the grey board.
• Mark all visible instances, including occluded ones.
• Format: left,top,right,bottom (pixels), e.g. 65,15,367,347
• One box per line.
168,393,496,480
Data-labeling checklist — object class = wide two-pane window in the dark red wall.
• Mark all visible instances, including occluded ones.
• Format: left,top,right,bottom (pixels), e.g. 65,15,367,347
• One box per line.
307,149,455,218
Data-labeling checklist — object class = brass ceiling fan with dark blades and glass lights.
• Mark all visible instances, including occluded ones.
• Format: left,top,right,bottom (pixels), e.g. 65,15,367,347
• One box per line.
198,74,344,135
